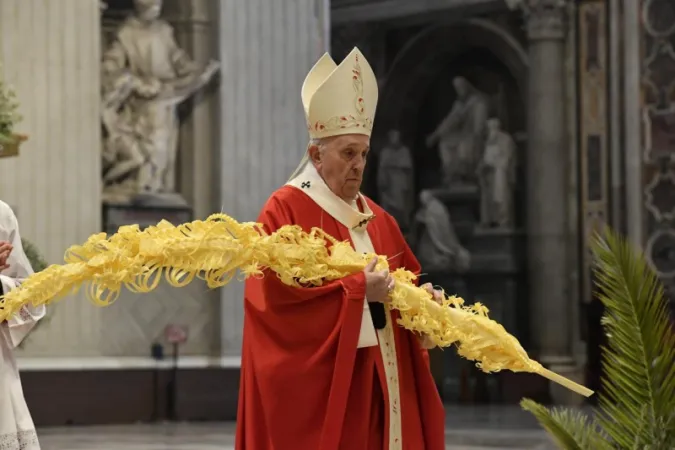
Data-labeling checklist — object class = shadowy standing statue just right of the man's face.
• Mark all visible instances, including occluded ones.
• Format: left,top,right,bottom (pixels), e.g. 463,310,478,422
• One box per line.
377,130,415,230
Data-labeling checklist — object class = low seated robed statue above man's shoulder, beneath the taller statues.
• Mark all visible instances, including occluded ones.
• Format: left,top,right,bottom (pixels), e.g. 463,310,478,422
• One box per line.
413,190,471,272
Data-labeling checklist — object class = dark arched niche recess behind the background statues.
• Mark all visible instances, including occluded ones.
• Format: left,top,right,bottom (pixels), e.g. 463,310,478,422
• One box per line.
366,19,528,212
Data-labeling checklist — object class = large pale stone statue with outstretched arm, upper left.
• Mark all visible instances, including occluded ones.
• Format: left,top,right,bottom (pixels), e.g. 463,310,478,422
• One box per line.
102,0,219,203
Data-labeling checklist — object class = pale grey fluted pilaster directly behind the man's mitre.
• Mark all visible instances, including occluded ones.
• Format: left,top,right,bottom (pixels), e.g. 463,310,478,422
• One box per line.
218,0,327,355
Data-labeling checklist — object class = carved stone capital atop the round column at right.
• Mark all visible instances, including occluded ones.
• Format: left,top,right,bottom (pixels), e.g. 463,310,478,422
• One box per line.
506,0,570,40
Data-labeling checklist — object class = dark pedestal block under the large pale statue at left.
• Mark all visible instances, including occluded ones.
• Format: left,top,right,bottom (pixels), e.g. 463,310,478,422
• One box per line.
103,203,193,234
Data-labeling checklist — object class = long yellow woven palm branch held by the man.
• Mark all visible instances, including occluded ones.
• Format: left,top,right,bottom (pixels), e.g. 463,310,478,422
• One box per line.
0,214,593,396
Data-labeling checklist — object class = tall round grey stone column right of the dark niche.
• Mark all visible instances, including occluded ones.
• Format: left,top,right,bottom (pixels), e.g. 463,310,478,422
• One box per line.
520,0,577,400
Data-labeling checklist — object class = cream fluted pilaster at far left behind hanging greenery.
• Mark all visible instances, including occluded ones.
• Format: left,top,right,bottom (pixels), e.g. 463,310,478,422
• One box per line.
0,0,101,357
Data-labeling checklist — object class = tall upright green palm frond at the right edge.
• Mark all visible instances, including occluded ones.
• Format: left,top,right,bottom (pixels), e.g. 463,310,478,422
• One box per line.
593,230,675,449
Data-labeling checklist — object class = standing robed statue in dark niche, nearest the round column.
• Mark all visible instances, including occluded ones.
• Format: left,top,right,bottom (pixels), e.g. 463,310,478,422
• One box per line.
477,118,516,228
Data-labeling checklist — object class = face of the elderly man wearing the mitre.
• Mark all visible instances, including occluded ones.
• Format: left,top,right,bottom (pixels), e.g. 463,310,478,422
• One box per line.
309,134,370,202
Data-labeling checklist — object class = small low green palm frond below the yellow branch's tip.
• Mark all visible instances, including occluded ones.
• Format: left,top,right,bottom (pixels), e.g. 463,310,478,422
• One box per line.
520,399,612,450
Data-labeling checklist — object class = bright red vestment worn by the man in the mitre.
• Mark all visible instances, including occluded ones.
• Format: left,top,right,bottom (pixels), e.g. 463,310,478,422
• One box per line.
235,186,445,450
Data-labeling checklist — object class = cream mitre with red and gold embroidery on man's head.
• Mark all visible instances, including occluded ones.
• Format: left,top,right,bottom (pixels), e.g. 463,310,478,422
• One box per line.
302,48,377,139
